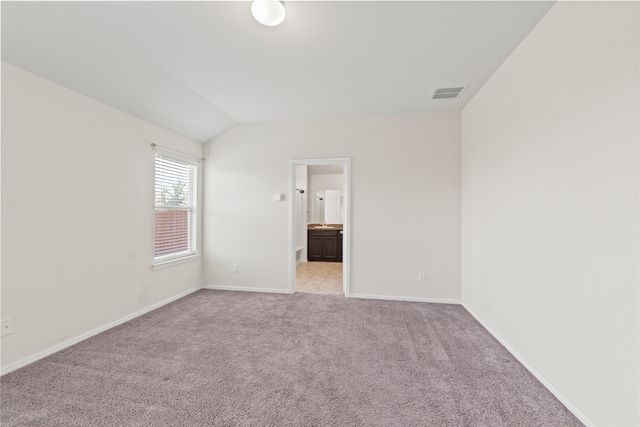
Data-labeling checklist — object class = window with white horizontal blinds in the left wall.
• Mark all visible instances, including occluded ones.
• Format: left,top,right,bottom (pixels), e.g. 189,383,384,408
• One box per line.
154,147,198,264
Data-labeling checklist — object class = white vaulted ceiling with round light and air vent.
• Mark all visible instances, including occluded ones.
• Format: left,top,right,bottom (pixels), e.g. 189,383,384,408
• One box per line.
2,1,553,142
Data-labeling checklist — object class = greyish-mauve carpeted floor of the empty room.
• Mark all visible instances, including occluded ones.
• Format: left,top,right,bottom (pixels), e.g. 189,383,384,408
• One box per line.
0,290,582,427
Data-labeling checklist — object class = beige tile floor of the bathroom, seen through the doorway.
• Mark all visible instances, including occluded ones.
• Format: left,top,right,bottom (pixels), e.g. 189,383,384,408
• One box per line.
296,261,342,294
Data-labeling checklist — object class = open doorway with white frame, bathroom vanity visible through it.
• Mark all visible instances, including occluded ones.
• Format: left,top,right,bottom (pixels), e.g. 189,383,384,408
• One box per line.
289,158,350,297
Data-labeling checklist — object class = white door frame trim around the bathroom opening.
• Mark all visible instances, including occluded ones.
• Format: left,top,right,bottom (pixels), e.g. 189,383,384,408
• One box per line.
289,157,351,297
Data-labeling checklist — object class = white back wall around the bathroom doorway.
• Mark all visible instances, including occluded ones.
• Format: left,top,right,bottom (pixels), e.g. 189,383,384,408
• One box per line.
203,113,460,301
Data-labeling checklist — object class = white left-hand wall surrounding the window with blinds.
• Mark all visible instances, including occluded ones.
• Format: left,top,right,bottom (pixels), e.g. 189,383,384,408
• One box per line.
2,63,203,369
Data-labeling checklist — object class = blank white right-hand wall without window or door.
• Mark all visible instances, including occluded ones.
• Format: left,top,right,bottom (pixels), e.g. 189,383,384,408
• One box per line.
462,2,640,426
